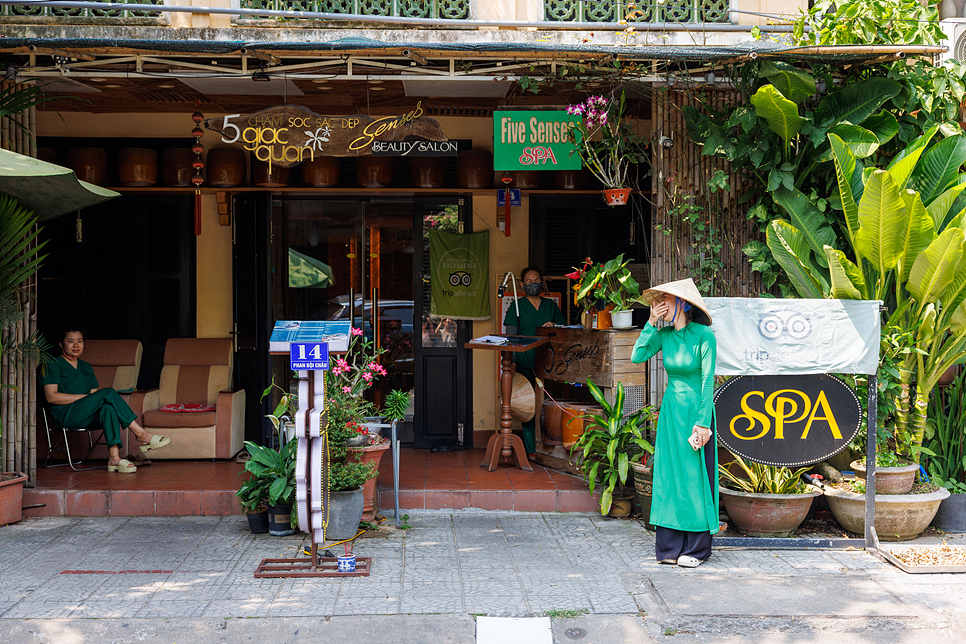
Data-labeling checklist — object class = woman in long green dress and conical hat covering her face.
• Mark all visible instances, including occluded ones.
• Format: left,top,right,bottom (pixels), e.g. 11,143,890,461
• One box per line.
631,278,718,568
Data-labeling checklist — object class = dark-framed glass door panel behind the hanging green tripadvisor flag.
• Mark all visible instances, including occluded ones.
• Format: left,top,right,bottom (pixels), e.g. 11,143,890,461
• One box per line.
413,198,472,449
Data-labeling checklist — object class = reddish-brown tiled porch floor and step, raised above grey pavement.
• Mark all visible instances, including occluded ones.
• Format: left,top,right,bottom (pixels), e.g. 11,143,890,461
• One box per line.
23,448,596,516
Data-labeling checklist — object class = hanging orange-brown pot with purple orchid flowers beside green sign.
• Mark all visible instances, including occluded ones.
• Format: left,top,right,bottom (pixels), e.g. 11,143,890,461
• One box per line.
567,92,647,206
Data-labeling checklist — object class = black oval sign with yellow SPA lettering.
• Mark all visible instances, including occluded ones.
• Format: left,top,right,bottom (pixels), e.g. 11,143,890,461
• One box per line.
714,375,862,466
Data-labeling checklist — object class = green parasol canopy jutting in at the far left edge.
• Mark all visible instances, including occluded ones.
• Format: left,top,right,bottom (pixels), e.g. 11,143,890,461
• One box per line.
0,149,121,221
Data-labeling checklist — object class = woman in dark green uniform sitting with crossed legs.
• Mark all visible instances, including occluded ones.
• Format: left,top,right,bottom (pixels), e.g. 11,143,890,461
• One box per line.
44,330,171,474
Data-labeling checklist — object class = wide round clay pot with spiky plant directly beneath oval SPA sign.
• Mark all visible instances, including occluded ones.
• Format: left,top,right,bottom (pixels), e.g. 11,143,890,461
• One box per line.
718,455,822,537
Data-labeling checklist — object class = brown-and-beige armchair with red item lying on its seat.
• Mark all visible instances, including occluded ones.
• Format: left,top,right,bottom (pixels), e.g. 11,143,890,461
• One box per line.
141,338,245,460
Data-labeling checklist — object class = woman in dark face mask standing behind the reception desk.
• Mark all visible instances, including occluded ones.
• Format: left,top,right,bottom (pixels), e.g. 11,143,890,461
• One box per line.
503,266,567,461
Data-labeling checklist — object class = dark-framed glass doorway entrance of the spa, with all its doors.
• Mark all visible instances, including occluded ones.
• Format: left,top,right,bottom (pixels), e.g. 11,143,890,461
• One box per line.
235,195,472,448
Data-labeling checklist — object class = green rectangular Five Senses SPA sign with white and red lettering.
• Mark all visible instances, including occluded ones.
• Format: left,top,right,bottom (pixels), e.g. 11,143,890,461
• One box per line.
493,110,581,170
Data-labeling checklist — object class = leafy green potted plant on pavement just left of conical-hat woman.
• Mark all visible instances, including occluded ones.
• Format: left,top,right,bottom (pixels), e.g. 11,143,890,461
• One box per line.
570,380,654,515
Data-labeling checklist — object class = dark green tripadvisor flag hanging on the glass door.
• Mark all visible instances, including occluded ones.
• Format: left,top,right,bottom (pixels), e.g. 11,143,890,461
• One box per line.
429,230,490,320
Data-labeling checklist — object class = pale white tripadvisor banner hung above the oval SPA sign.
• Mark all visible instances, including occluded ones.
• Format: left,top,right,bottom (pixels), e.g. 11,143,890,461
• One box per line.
704,297,881,376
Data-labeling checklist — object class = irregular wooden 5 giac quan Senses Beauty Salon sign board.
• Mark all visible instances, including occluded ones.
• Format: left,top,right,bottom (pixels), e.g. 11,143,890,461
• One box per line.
205,101,456,172
